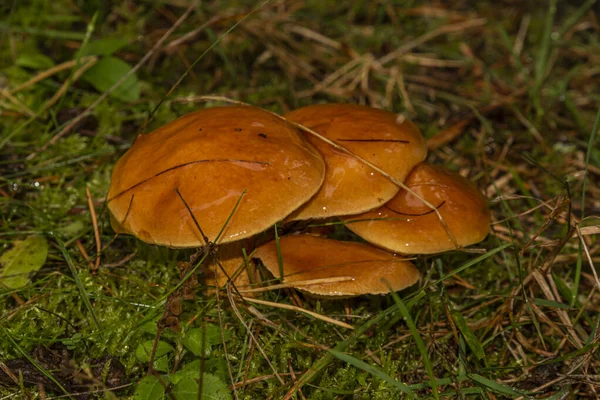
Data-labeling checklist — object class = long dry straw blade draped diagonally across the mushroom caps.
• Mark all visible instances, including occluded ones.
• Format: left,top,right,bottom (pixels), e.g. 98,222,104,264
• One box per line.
197,96,461,249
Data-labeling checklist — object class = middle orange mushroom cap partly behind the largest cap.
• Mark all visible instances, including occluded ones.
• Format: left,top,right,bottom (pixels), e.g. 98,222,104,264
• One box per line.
284,104,427,220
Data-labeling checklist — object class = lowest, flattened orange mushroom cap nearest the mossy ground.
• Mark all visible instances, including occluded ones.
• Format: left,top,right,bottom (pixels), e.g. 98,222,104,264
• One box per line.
254,235,419,297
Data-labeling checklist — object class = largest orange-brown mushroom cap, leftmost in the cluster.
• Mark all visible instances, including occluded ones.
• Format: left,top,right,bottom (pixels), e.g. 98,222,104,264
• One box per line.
108,107,325,247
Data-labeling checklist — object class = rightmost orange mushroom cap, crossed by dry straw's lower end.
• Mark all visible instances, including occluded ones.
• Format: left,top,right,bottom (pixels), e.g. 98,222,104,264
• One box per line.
342,163,490,254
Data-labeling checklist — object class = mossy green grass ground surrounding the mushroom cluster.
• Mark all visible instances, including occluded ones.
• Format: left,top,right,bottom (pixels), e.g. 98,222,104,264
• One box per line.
0,0,600,399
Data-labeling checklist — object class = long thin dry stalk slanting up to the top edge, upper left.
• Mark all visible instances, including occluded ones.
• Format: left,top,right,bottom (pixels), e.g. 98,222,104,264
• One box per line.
27,4,196,160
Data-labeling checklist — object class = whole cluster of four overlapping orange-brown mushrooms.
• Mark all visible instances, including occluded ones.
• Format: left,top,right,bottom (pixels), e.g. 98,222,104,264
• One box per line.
107,104,490,297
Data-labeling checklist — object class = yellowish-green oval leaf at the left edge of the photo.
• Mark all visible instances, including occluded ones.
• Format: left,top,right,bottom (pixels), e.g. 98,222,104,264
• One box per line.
0,236,48,289
